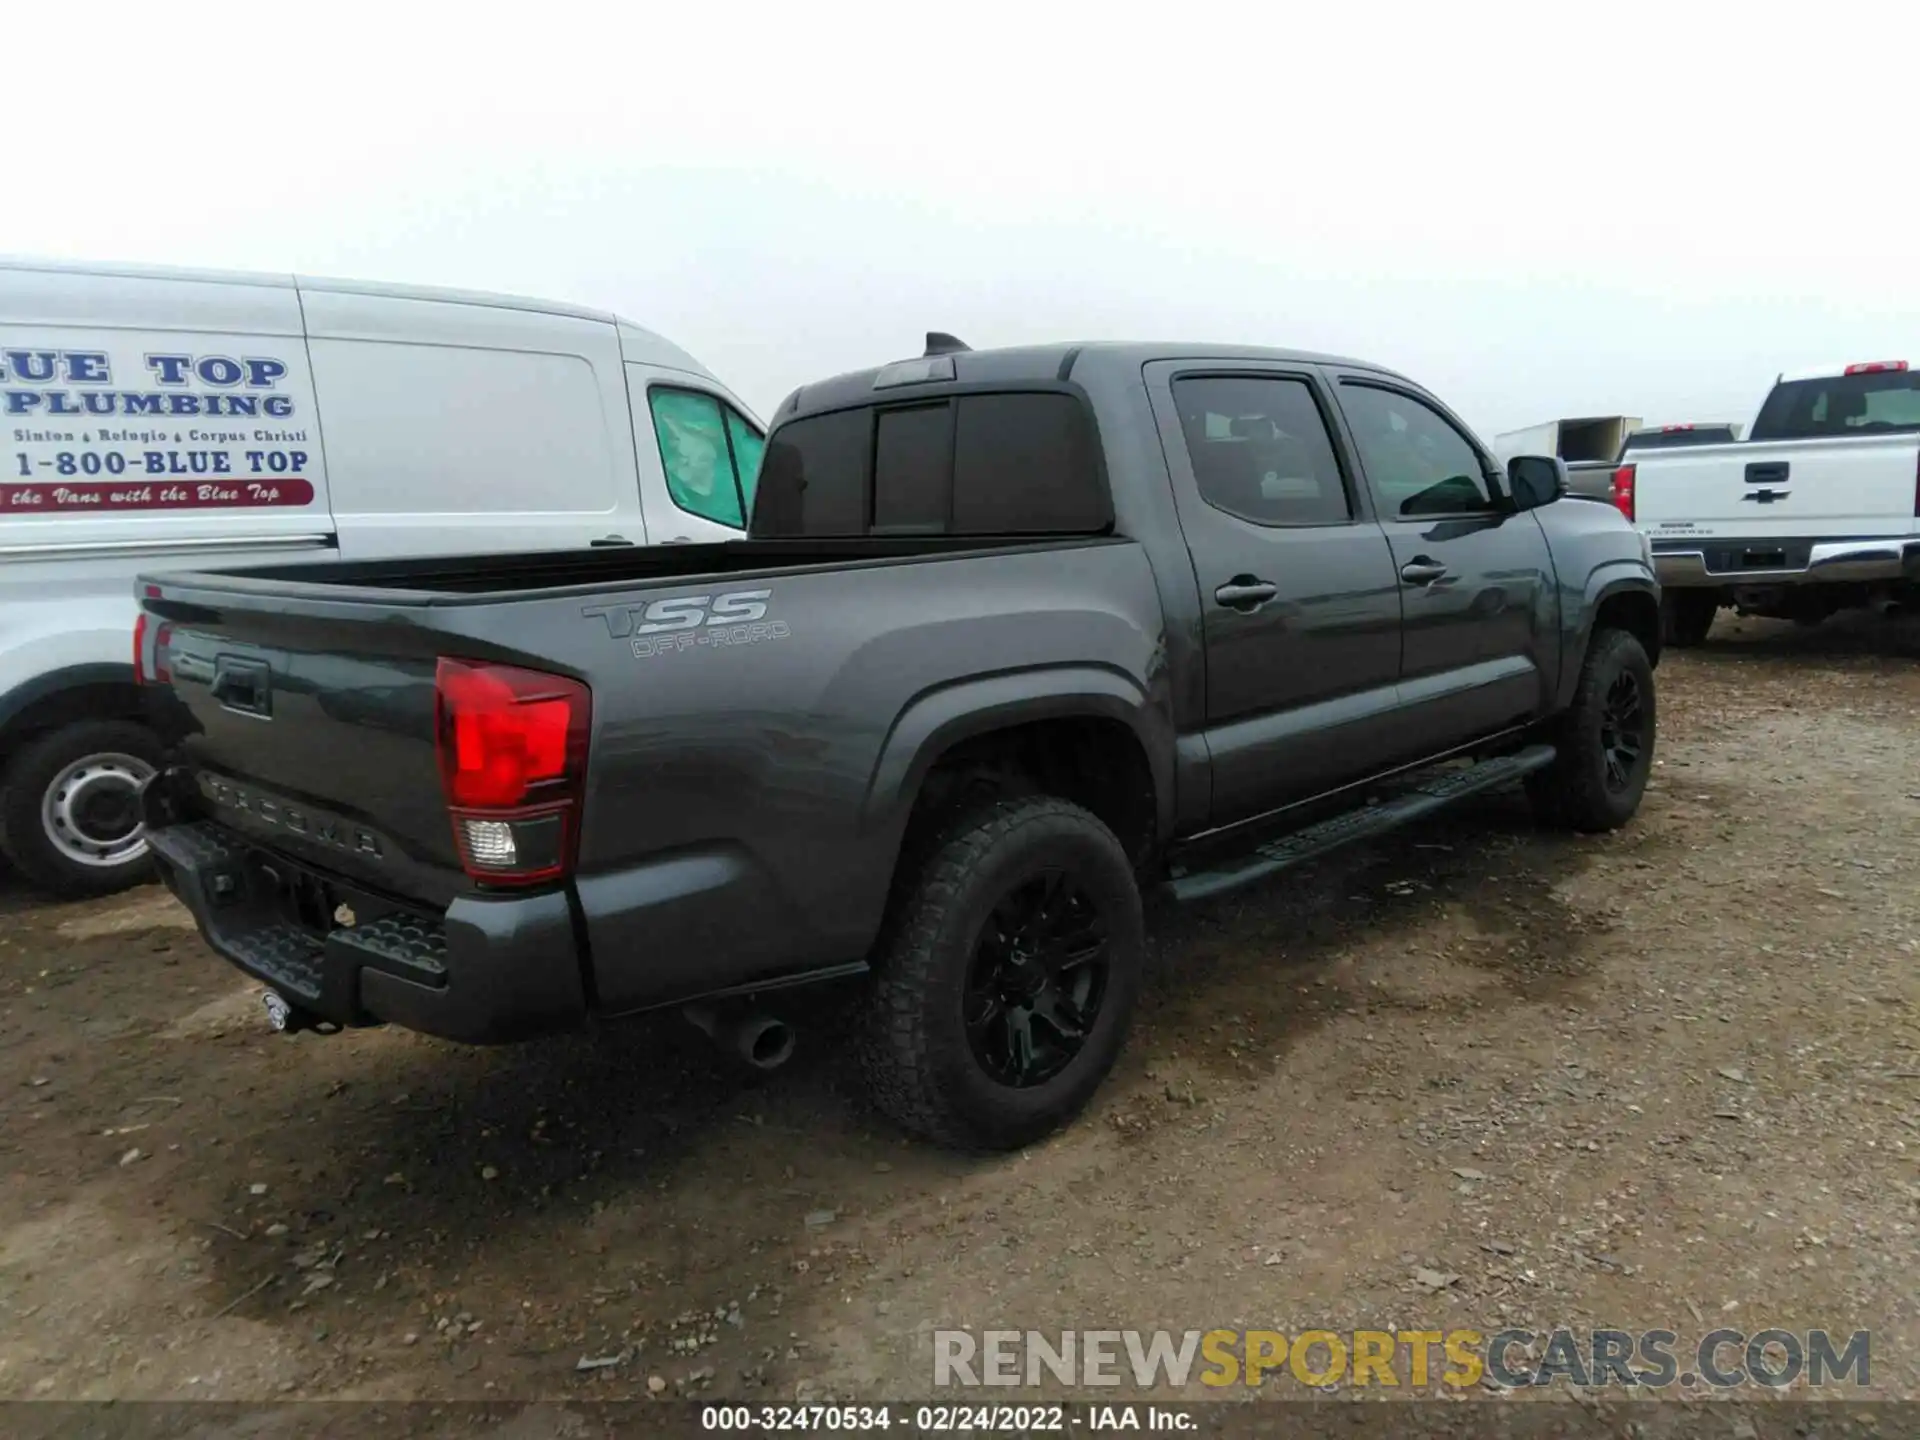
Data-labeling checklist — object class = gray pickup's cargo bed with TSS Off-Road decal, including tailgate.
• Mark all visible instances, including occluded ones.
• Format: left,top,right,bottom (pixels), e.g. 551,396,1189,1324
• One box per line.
140,536,1171,1012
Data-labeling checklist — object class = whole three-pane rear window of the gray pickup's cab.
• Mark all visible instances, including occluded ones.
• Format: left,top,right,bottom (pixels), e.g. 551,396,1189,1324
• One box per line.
753,392,1112,538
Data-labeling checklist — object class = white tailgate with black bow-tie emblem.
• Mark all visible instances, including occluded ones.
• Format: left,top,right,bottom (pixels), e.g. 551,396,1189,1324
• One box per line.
1630,434,1920,540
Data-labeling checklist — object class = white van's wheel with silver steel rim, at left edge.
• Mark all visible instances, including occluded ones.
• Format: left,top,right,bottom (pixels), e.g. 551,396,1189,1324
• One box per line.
0,720,161,899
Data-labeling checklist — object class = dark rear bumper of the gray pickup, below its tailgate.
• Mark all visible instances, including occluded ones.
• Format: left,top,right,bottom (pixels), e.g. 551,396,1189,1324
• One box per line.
148,814,588,1044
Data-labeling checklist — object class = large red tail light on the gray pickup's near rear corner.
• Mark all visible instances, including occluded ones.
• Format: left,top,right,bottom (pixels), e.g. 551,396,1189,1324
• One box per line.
434,659,593,885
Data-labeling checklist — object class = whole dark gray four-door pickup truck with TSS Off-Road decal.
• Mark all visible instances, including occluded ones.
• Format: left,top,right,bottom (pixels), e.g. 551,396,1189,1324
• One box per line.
136,336,1661,1148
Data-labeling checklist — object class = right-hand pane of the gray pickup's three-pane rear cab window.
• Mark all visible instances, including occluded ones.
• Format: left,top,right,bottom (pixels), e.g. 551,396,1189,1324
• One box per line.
954,394,1112,536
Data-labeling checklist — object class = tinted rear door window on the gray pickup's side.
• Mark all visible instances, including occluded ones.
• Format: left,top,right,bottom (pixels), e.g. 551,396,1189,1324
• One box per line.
1173,376,1352,524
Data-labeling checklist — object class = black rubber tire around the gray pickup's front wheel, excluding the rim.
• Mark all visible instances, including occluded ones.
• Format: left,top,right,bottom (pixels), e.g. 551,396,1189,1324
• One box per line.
1526,630,1659,833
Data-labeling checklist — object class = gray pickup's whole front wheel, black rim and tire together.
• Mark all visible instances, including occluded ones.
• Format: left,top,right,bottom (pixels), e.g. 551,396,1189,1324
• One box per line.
1526,630,1657,833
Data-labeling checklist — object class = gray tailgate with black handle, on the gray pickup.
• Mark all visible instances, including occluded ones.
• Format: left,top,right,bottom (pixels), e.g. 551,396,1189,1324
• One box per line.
148,595,468,904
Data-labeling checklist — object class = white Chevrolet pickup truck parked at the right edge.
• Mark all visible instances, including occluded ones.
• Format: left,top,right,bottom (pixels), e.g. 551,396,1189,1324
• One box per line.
1613,361,1920,645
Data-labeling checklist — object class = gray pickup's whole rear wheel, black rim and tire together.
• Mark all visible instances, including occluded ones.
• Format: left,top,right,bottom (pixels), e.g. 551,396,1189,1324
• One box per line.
860,795,1146,1150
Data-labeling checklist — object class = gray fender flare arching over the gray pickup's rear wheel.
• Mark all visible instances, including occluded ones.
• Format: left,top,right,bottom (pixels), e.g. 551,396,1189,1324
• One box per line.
860,664,1173,841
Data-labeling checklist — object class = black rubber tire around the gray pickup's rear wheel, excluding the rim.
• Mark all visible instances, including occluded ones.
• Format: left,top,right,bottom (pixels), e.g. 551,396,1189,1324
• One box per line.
860,795,1146,1150
